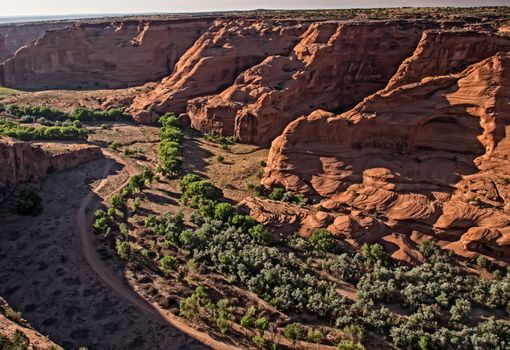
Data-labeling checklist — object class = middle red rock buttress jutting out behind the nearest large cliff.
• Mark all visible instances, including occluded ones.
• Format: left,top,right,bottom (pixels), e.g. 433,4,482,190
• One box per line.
188,21,437,145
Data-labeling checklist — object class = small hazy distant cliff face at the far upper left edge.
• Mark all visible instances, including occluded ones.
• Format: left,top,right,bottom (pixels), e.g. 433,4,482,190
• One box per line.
0,22,72,63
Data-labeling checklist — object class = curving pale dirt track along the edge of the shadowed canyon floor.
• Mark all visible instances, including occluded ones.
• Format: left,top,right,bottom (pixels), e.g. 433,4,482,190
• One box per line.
76,150,238,350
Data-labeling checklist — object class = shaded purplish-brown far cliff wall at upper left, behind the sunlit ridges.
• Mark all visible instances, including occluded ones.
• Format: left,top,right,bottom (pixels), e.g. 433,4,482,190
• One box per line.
0,19,212,89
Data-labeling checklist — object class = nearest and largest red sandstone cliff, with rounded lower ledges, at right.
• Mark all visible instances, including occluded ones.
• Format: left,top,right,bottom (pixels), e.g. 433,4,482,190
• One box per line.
263,53,510,260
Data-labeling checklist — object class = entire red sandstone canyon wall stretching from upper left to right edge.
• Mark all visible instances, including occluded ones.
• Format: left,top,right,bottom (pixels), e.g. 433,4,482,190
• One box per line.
0,9,510,264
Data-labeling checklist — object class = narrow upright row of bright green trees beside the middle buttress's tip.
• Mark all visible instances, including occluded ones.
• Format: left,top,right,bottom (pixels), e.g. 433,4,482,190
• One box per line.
158,113,184,176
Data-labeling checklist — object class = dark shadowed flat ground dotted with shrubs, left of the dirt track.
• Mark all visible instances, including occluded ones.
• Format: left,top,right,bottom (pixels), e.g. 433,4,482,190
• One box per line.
0,159,207,349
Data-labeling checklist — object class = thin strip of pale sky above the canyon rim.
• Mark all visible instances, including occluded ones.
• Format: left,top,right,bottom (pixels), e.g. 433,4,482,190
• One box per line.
0,0,510,17
